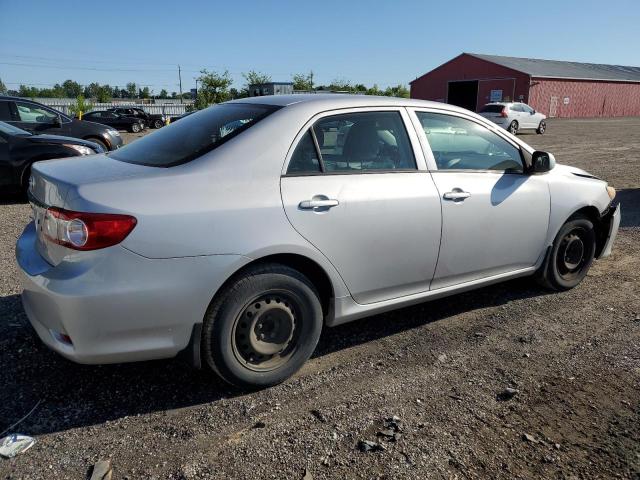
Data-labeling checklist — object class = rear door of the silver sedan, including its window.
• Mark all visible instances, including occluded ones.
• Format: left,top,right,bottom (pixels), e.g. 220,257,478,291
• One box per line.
281,109,441,304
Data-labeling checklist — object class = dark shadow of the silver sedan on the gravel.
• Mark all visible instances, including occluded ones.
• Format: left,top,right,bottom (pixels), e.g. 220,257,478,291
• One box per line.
0,279,546,435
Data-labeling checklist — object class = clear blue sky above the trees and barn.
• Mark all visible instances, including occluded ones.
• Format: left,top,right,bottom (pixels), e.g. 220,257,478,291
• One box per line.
0,0,640,93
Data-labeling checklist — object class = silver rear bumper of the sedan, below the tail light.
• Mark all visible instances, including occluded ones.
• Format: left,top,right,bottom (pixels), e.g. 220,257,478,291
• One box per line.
16,223,244,364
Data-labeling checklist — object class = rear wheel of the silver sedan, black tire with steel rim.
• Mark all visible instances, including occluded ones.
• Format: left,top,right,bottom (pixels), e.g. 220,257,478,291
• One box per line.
200,264,323,389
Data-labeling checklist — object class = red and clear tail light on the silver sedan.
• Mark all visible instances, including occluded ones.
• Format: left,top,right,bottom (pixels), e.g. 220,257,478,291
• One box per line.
42,207,137,250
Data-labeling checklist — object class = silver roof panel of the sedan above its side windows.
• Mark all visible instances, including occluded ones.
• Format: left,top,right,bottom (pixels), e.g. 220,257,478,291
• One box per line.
227,93,467,112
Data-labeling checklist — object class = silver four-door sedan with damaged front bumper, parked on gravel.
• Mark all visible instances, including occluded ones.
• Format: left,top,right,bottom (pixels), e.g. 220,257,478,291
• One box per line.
16,95,620,387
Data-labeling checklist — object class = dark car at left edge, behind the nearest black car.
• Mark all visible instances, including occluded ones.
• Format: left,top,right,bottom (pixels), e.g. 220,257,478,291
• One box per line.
0,96,122,150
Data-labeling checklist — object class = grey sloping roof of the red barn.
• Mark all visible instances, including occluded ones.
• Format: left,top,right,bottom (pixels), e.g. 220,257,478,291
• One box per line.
467,53,640,82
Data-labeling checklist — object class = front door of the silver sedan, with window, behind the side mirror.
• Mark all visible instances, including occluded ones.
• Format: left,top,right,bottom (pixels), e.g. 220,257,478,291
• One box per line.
414,110,550,289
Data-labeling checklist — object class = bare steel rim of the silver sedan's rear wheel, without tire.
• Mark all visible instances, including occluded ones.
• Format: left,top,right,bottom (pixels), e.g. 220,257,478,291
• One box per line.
232,292,301,372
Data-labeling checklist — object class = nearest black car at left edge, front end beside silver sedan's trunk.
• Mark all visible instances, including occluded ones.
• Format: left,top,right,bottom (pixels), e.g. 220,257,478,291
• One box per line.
0,122,104,192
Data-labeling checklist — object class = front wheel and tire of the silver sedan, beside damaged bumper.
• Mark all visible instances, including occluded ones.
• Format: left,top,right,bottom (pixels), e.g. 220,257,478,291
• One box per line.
537,216,596,290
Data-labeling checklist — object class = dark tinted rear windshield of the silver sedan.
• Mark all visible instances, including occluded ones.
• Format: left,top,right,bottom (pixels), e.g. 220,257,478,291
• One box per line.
109,103,280,167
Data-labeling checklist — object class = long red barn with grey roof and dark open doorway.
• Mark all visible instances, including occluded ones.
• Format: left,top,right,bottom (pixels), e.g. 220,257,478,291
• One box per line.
411,53,640,117
